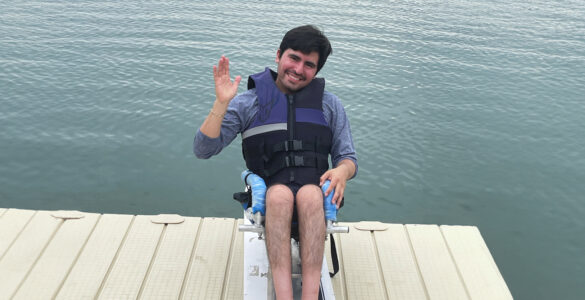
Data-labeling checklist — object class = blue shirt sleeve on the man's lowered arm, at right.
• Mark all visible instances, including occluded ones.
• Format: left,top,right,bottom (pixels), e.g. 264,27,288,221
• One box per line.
323,92,358,178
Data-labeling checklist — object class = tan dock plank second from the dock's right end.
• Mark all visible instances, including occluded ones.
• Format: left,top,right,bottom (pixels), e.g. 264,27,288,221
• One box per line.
406,225,469,300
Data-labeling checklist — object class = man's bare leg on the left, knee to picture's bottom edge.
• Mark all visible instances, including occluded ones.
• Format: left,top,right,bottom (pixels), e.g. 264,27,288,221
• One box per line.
265,184,294,300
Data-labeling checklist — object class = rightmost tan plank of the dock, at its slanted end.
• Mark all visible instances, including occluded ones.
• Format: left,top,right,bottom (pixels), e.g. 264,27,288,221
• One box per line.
441,225,512,300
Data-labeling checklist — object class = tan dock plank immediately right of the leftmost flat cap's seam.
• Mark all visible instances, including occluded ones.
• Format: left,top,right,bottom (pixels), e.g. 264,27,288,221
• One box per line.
13,214,100,300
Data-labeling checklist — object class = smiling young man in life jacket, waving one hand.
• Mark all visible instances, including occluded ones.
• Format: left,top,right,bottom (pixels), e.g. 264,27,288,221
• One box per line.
193,25,357,300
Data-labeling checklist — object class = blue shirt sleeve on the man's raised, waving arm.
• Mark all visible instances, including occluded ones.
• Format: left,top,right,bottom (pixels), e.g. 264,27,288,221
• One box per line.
193,92,255,159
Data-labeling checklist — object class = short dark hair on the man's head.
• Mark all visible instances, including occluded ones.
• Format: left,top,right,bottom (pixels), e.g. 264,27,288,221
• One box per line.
279,25,333,72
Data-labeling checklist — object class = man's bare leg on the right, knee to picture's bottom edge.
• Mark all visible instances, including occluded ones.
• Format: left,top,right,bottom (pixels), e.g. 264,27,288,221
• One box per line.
297,184,325,300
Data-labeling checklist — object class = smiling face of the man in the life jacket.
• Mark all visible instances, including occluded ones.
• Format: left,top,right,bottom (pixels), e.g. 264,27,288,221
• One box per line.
276,48,319,94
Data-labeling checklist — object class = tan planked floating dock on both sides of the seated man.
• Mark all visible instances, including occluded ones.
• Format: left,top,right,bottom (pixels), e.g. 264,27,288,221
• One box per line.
0,208,512,300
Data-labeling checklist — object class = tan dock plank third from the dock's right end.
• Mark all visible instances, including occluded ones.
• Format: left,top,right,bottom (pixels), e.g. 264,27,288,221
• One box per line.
374,224,428,299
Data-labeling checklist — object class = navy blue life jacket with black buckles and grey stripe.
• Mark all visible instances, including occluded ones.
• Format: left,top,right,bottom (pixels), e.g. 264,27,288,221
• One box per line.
242,68,333,186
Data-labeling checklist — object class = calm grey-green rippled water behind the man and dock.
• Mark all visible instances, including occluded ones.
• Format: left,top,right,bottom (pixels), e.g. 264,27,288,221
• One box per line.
0,0,585,299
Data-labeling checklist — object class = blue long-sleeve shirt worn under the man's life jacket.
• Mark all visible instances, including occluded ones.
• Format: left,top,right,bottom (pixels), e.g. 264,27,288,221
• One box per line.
193,89,358,177
